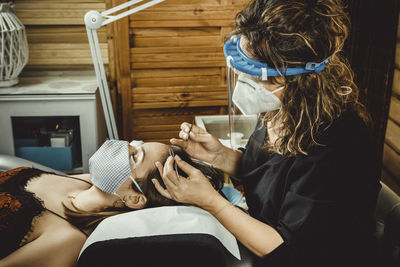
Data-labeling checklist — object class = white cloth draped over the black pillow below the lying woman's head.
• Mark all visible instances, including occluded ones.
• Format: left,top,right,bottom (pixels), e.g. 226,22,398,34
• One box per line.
80,206,240,260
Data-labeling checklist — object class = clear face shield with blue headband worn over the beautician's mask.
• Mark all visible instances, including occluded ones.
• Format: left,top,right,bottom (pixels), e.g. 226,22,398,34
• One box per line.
224,36,327,149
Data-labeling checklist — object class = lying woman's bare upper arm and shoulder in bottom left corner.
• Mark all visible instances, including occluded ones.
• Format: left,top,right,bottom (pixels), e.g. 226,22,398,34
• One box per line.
0,229,86,267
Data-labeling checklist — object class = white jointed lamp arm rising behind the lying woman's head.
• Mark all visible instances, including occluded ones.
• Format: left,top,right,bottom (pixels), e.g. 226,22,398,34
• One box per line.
85,0,164,140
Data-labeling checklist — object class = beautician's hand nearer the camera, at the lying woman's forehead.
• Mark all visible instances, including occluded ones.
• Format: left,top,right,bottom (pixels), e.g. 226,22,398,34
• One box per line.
152,156,219,208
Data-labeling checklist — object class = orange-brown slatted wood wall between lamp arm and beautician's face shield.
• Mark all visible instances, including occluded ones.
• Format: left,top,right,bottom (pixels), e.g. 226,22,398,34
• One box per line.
119,0,247,142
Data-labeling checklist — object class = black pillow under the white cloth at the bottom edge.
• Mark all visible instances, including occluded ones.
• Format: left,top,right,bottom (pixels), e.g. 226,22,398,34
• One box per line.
77,234,234,267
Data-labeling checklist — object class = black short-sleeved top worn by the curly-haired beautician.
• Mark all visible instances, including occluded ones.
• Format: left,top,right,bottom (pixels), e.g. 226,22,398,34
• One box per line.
239,113,380,267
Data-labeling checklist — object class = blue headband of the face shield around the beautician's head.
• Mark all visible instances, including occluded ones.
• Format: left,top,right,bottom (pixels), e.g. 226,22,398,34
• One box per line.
224,36,328,80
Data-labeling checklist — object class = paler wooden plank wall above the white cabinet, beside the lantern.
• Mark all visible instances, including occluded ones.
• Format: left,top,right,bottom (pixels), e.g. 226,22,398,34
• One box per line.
15,0,108,70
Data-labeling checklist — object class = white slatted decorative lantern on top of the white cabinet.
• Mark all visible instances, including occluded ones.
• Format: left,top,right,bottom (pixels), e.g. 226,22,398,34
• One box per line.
0,2,29,87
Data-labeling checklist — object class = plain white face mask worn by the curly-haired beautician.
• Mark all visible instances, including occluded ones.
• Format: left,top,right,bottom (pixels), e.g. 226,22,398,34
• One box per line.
232,74,285,115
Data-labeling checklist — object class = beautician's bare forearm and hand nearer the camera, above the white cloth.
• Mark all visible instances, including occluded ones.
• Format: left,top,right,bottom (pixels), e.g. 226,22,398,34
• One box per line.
152,157,283,256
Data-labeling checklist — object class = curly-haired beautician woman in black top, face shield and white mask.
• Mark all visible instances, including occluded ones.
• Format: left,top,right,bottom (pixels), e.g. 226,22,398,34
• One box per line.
153,0,380,267
